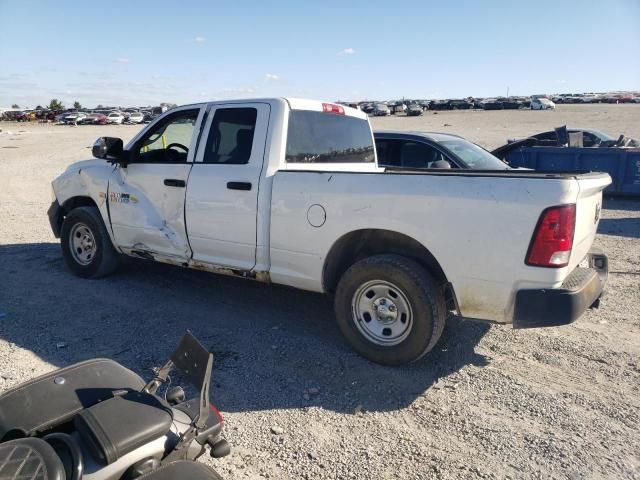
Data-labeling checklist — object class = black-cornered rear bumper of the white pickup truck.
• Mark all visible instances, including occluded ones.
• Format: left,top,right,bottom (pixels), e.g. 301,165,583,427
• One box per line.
513,249,609,328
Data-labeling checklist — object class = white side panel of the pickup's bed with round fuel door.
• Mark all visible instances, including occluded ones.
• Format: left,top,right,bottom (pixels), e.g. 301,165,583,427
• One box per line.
270,169,610,323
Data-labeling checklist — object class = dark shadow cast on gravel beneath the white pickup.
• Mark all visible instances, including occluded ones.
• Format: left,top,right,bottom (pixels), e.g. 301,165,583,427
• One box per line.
0,243,490,413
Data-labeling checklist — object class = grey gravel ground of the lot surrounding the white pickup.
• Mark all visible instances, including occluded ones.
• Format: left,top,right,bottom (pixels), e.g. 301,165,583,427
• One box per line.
0,105,640,480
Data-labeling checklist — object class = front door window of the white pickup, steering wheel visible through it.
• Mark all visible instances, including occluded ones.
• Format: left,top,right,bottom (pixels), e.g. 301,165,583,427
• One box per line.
136,109,199,163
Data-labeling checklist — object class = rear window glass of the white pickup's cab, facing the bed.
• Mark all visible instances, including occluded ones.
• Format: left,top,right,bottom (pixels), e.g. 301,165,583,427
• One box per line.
286,110,375,163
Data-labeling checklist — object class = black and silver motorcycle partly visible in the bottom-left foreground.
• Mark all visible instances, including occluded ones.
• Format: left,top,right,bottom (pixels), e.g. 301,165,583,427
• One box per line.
0,331,230,480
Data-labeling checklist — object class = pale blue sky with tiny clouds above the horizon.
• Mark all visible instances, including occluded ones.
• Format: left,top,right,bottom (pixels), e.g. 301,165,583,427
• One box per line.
0,0,640,107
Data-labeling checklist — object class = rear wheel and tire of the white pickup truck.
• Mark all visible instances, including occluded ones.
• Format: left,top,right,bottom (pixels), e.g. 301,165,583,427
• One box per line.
334,255,447,365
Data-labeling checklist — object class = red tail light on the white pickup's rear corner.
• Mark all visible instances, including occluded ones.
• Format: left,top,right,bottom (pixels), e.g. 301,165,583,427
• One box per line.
526,205,576,268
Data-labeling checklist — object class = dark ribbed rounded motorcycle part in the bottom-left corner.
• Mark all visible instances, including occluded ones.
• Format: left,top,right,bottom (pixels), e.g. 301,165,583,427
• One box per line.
0,438,67,480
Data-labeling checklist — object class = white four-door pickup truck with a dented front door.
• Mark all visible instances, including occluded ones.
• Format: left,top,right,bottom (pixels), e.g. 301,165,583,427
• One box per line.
48,98,611,364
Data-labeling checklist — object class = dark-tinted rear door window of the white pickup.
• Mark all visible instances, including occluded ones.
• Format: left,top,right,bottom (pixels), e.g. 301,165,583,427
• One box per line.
204,108,258,165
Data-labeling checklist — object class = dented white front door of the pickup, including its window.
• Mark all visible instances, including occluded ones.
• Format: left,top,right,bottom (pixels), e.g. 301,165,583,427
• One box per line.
107,107,204,262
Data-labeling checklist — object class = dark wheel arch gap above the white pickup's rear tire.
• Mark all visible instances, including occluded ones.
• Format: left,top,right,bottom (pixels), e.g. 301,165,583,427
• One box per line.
322,229,455,303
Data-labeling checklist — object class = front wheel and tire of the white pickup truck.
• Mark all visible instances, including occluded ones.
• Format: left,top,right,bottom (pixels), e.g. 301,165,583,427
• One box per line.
60,207,118,278
